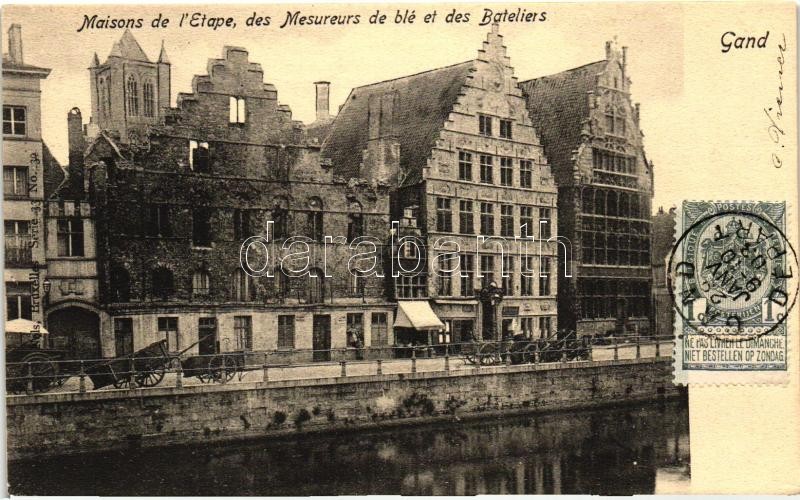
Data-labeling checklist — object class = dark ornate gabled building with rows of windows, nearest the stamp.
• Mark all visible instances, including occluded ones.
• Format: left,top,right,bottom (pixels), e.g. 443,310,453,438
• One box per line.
520,42,653,335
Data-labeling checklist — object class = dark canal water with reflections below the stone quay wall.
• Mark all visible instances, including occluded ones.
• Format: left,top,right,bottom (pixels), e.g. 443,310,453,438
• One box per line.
9,402,689,496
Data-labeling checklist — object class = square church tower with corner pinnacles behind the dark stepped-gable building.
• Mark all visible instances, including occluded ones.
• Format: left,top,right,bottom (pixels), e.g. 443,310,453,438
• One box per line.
89,30,171,142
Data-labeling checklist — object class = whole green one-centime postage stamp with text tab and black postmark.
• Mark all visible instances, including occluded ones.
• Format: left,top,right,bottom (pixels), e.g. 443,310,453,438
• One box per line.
667,201,798,384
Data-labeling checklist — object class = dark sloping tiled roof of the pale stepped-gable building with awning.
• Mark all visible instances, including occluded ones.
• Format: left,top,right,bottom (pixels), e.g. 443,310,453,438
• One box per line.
323,61,474,185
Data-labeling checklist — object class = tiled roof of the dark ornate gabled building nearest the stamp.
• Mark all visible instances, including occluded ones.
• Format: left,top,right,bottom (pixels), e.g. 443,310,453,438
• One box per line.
520,60,607,180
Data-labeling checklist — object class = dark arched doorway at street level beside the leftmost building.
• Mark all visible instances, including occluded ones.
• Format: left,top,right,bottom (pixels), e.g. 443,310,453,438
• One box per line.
47,306,100,359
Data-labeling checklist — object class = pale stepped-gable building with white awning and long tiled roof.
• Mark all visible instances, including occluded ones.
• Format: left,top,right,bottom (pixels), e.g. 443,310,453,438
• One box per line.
323,26,558,342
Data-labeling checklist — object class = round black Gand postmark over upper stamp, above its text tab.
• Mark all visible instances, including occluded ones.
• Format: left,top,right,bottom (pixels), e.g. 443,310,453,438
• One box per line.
667,203,798,339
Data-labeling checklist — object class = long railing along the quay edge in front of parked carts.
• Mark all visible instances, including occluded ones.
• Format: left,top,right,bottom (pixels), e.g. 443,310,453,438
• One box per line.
6,336,673,394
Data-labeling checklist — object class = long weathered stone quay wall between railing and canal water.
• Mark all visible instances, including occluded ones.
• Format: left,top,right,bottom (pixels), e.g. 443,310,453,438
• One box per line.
6,358,677,459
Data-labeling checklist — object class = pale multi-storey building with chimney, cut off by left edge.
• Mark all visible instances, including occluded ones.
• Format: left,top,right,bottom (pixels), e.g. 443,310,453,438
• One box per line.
3,24,50,323
